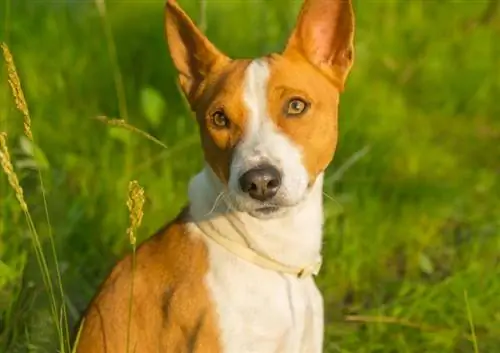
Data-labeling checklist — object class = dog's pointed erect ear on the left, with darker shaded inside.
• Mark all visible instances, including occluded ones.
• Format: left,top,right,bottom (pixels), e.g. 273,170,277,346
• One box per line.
165,0,229,103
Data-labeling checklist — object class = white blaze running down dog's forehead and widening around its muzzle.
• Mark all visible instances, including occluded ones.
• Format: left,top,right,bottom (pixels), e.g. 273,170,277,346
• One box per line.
229,59,309,211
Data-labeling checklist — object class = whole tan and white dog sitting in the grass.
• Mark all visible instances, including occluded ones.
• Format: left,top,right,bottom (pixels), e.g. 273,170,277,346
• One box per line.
76,0,354,353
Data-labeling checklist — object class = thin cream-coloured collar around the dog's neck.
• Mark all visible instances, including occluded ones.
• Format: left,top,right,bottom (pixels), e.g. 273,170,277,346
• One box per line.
195,217,322,278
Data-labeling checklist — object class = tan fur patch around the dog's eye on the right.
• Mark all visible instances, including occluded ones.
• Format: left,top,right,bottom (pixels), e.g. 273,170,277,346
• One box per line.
268,55,339,183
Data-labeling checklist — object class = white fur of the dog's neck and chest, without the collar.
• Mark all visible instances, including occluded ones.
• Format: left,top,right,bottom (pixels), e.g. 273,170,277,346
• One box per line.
189,170,323,353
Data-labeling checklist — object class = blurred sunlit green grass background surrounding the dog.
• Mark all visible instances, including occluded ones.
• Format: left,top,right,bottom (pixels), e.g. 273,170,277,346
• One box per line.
0,0,500,353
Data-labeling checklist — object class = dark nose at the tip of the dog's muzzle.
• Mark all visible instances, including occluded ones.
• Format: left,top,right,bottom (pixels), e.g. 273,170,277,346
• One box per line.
240,164,281,201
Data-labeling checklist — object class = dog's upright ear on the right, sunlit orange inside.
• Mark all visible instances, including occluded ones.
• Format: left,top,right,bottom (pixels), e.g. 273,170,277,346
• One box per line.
284,0,354,90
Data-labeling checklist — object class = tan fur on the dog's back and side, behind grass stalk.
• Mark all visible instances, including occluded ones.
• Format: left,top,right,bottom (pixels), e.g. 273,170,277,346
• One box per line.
76,208,220,353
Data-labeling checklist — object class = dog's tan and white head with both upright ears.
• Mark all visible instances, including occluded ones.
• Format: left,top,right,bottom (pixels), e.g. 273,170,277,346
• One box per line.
166,0,354,218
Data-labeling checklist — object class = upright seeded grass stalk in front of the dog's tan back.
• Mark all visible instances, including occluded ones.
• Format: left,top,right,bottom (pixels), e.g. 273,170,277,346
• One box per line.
126,180,145,353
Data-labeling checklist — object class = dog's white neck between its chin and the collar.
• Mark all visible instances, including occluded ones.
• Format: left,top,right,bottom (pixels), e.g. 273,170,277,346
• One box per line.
189,167,323,266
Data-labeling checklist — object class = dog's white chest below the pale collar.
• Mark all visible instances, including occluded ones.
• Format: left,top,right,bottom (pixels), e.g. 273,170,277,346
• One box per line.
206,242,321,353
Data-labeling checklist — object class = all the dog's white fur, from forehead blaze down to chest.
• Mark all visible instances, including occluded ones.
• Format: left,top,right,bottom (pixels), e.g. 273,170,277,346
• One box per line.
189,61,323,353
